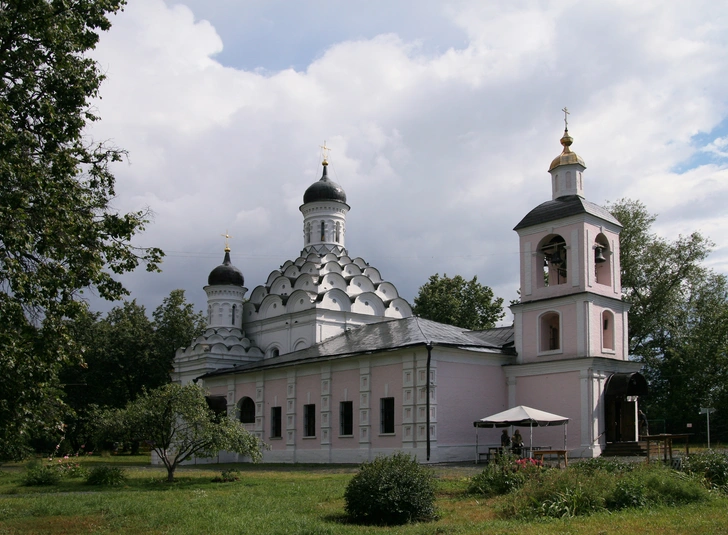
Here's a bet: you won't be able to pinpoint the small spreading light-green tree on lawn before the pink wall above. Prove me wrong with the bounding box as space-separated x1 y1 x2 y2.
99 383 264 482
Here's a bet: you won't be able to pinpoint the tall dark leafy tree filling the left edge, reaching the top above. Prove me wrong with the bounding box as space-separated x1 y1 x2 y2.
0 0 162 458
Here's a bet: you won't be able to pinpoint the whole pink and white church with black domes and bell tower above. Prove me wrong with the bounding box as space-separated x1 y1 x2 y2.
174 123 646 463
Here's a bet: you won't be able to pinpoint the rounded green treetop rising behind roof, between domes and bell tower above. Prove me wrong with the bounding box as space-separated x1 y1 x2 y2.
413 273 505 330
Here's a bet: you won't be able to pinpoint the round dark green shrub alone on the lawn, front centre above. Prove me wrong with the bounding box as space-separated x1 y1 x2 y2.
344 452 435 525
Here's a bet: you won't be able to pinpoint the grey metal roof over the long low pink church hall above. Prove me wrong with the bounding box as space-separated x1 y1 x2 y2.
203 316 515 377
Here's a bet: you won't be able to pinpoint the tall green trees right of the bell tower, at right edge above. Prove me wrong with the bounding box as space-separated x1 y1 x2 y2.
606 199 728 436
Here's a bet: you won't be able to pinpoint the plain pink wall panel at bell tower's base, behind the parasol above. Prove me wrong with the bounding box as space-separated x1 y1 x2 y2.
516 372 582 449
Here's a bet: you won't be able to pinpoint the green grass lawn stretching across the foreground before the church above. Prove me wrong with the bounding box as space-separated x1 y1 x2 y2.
0 456 728 535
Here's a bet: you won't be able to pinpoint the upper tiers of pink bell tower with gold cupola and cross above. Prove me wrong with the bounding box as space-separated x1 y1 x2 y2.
512 118 629 363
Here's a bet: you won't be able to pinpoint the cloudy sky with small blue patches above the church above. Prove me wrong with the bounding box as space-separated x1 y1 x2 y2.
87 0 728 323
